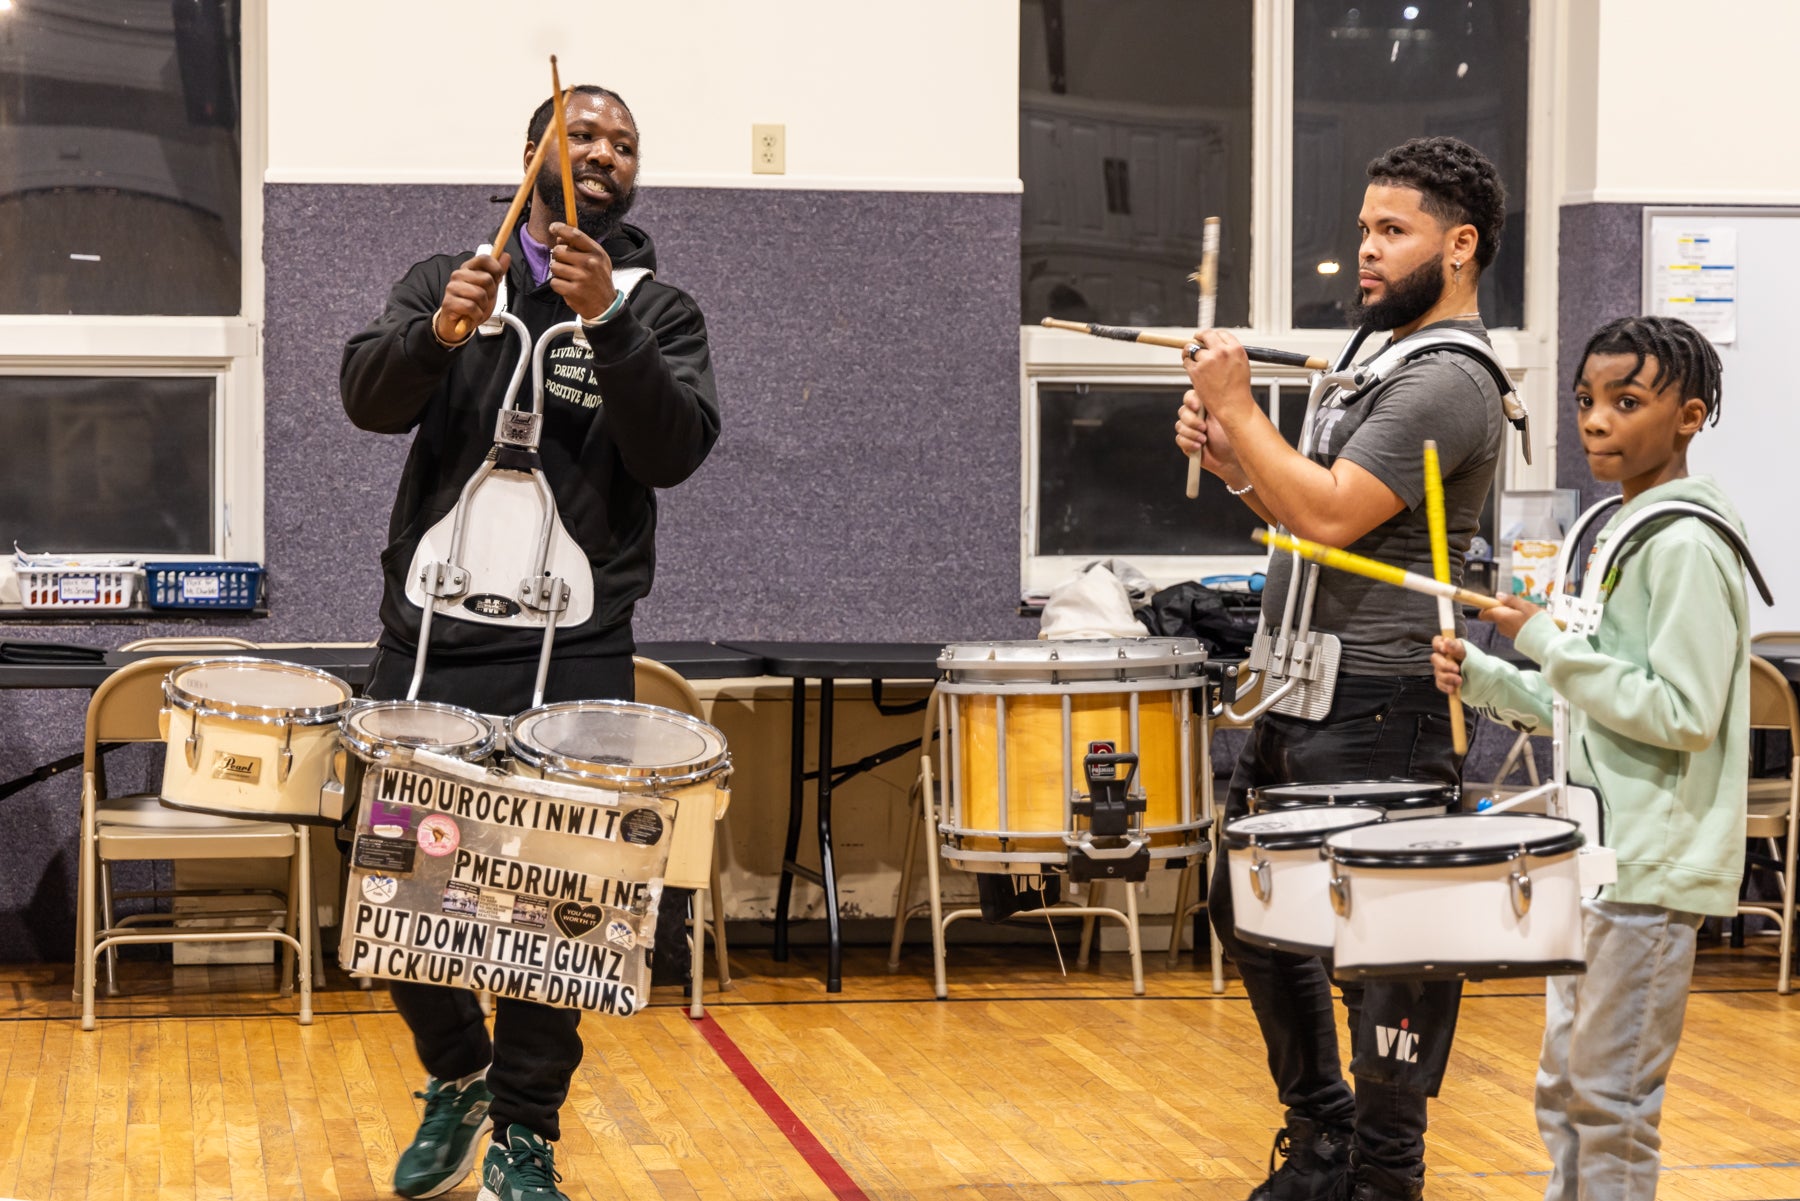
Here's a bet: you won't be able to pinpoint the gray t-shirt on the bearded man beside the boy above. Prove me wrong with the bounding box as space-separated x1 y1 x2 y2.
1262 319 1507 675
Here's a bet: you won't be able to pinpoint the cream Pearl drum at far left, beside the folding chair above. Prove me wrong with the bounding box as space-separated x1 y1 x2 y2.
162 659 351 825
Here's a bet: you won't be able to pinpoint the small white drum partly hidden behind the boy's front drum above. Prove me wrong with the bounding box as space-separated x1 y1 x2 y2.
1226 805 1382 954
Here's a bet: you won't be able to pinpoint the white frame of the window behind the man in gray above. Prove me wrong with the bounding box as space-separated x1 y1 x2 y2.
1019 0 1568 592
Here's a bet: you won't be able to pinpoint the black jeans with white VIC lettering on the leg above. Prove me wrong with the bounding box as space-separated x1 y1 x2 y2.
1208 675 1462 1176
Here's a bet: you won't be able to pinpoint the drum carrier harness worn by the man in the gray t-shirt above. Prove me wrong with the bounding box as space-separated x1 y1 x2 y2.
1224 330 1532 722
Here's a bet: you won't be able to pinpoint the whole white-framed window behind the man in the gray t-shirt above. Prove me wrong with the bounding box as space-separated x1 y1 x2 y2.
1019 0 1557 592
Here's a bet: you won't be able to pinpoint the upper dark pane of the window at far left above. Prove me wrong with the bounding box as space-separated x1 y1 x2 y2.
0 0 241 317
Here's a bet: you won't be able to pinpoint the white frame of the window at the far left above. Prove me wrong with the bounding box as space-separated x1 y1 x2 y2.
0 0 268 562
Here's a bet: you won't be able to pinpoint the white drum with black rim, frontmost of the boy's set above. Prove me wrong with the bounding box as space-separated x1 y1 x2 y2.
1325 814 1586 980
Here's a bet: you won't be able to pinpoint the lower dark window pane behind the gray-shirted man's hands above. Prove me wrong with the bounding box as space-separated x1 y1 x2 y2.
1037 384 1269 558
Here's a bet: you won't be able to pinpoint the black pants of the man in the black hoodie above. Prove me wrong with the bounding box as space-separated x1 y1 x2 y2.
369 648 637 1142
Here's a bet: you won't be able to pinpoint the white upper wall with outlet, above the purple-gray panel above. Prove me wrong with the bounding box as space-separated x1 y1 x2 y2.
266 0 1019 191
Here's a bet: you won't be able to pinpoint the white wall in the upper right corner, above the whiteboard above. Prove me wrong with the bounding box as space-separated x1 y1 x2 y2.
1559 0 1800 203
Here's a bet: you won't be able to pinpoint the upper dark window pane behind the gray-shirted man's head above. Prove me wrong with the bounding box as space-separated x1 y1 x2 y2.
1292 0 1532 328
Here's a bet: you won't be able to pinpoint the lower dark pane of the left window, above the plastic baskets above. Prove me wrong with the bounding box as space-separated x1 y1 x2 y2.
0 375 214 555
